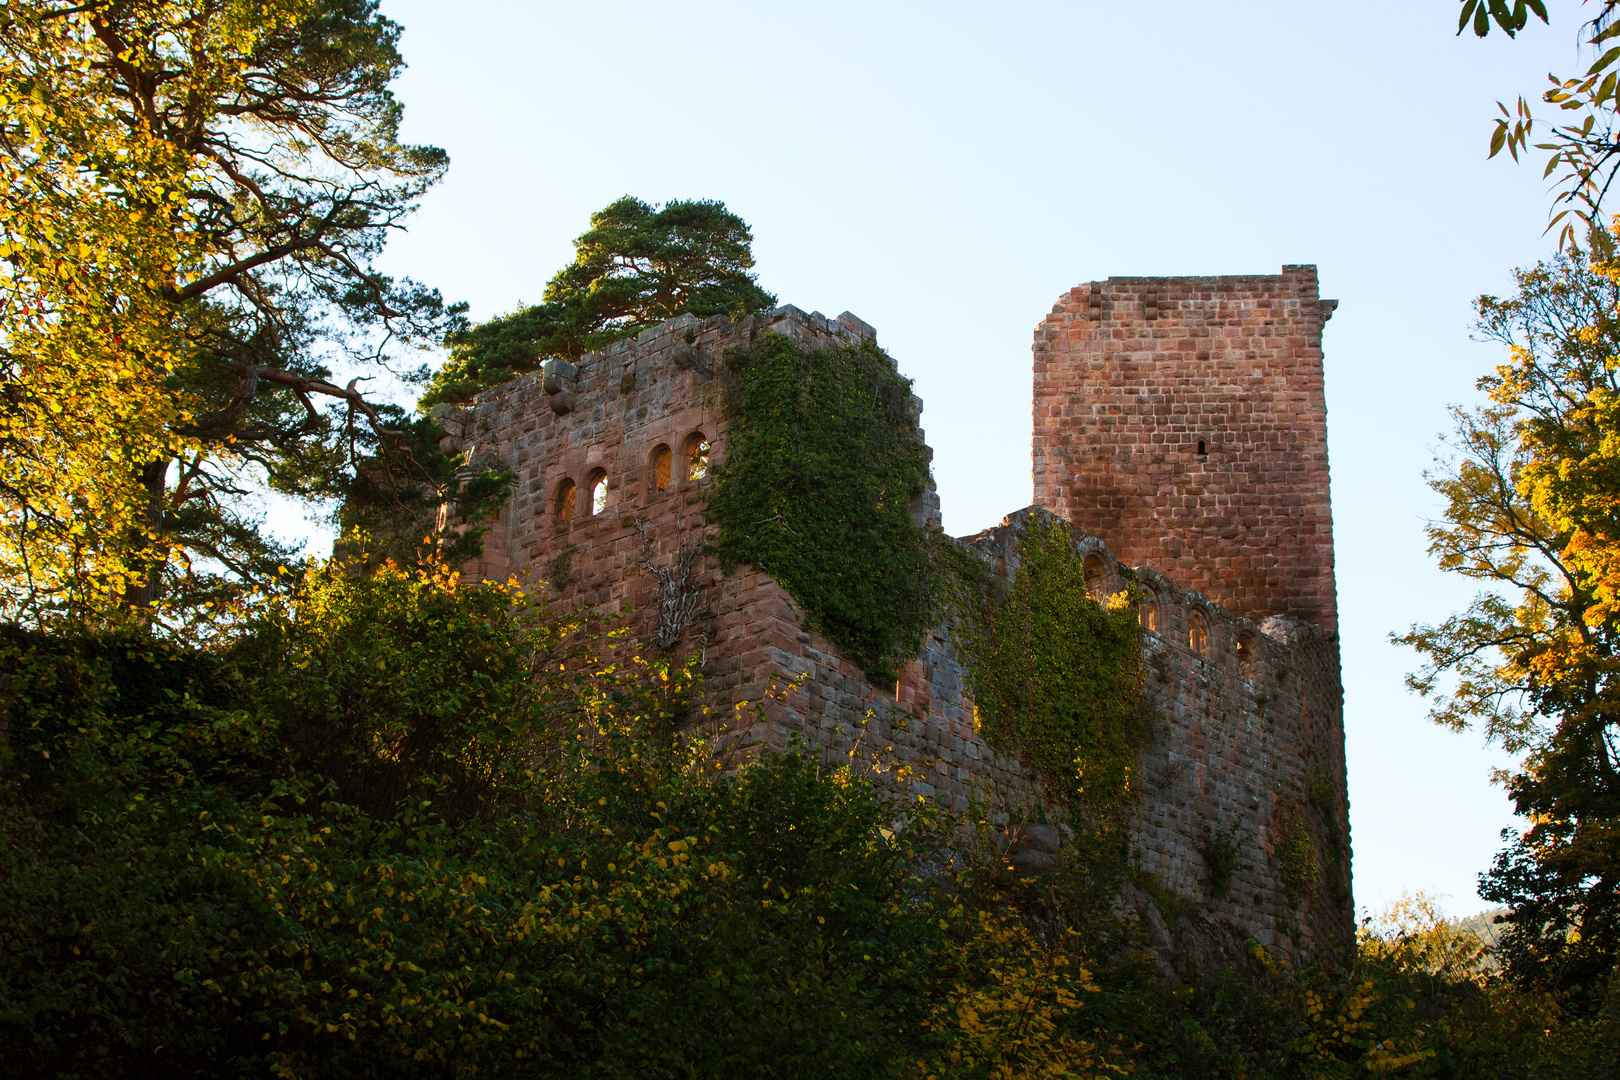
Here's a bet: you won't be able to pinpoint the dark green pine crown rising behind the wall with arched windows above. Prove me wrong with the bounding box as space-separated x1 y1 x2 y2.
421 196 776 406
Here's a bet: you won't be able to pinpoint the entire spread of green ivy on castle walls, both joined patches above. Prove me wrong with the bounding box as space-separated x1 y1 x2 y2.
708 334 1149 809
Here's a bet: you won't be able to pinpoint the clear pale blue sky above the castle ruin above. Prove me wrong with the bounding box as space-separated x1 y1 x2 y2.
345 0 1581 913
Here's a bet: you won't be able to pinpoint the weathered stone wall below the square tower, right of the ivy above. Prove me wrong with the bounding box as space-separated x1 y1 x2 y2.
953 507 1354 952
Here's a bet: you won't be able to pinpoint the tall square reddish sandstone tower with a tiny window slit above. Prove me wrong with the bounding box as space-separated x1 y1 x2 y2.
1034 266 1338 630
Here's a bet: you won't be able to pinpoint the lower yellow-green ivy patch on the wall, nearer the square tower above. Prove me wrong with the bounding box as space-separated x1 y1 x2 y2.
956 521 1150 818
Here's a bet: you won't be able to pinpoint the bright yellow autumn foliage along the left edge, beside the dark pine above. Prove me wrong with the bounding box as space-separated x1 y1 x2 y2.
0 0 325 625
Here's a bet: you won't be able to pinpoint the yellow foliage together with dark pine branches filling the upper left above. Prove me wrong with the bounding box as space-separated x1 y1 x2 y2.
0 0 505 634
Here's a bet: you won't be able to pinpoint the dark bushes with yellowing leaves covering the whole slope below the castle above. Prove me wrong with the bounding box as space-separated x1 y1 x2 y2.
0 567 1620 1078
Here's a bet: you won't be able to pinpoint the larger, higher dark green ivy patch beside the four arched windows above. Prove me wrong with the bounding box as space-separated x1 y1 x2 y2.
708 334 935 683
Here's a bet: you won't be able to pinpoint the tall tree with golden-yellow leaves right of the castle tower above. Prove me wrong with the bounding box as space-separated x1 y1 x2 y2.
1398 247 1620 986
